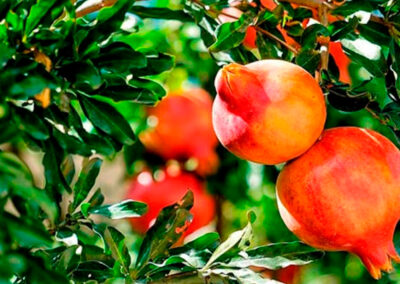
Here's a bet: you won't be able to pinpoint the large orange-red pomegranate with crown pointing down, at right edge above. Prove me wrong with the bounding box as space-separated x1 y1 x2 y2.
277 127 400 279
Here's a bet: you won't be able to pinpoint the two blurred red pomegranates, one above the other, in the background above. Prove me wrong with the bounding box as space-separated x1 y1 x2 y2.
127 89 219 235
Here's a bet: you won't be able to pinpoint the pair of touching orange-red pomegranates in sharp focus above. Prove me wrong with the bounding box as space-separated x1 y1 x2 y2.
212 60 400 279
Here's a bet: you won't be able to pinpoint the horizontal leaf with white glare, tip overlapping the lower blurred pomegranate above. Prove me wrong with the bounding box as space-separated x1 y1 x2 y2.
88 200 148 219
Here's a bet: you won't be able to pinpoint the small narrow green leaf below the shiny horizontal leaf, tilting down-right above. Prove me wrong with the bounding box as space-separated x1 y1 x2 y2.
104 227 131 275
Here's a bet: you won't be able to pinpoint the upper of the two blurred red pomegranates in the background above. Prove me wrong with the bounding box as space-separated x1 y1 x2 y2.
139 89 219 175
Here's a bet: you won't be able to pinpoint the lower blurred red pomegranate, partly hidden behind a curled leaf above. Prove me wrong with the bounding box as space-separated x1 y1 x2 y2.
127 170 215 235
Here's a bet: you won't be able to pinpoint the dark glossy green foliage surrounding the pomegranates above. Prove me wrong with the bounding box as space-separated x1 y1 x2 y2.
0 0 400 283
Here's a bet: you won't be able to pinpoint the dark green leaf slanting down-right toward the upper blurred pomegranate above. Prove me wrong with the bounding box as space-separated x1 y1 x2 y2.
79 95 135 145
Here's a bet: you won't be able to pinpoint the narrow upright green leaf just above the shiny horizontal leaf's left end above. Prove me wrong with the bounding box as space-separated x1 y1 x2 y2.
72 158 102 211
